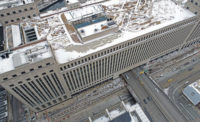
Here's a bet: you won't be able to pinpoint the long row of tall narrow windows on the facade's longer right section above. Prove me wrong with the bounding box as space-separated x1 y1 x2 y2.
63 25 195 95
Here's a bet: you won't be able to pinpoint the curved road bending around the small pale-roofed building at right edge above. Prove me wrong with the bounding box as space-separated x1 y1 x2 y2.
168 63 200 121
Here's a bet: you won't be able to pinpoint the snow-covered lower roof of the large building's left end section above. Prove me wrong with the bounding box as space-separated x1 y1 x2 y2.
0 41 52 74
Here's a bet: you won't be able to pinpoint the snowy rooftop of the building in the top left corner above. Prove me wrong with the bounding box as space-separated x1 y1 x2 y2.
0 0 34 10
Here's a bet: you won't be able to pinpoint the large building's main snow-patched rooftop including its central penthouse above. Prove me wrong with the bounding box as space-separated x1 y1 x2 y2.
0 0 195 74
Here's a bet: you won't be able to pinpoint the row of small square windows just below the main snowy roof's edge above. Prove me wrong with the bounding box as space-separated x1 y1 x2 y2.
60 19 196 71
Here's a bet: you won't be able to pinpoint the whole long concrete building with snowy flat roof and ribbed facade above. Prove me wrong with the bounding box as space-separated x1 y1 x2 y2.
0 0 200 112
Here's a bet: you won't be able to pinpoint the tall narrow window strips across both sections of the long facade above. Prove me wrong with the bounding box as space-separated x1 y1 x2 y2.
5 21 199 109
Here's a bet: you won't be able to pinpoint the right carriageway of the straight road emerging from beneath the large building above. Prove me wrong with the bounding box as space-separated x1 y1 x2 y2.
132 68 187 122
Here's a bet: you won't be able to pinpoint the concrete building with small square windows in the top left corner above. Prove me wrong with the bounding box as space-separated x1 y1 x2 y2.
0 0 39 25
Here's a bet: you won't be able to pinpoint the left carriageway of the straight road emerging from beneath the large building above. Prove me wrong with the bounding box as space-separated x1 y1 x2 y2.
123 71 168 122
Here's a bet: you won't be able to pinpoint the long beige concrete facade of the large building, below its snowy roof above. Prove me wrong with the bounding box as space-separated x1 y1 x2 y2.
0 16 200 112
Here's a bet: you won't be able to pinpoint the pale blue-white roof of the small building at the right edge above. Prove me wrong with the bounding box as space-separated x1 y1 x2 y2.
183 80 200 105
